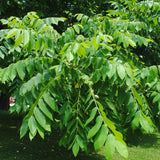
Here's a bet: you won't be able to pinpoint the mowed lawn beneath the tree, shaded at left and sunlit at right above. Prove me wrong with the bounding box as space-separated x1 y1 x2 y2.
0 112 160 160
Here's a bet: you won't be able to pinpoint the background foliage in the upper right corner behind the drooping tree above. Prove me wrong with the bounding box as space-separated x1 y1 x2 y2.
109 0 160 65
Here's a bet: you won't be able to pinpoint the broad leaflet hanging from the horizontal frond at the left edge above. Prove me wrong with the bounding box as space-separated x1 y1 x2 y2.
16 61 25 80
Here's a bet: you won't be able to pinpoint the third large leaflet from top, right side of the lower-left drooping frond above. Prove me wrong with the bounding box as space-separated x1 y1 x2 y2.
34 107 46 129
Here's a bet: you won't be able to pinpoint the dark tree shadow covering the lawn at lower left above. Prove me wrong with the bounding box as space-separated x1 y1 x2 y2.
0 113 105 160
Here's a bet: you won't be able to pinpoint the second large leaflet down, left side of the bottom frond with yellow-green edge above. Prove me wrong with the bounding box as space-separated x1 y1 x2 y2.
87 116 103 139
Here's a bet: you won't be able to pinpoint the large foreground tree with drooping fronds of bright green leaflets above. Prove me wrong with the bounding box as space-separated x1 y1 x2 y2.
0 0 160 159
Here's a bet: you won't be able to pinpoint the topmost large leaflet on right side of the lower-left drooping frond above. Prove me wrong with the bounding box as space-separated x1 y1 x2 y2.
43 92 58 112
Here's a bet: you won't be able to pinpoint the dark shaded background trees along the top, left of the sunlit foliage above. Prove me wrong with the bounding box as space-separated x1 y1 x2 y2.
0 0 110 18
